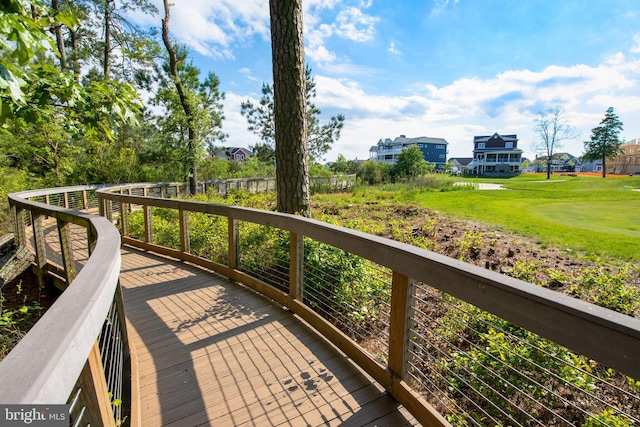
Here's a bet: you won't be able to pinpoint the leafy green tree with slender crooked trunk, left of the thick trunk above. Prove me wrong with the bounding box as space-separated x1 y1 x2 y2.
155 0 225 194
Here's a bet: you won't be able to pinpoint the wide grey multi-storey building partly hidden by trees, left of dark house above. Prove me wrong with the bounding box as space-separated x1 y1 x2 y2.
369 135 449 169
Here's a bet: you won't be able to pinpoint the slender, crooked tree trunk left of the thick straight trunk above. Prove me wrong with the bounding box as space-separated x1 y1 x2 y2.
162 0 198 195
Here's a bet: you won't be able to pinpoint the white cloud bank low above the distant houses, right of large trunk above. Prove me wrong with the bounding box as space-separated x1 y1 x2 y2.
300 50 640 164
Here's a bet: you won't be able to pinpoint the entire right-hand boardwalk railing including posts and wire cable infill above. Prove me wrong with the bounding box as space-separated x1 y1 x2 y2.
98 186 640 425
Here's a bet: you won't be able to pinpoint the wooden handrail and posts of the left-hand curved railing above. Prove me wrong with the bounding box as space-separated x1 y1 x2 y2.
0 186 126 425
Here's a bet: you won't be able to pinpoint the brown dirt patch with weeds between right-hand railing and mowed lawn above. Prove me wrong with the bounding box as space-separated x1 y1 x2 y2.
314 201 640 317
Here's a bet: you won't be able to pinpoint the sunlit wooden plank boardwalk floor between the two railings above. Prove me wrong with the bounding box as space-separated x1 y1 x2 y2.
120 247 417 426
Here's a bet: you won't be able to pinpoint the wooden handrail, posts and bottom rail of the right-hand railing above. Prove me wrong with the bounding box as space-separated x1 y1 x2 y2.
97 186 640 425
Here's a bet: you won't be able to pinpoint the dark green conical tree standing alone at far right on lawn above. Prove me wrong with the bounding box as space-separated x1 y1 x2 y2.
583 107 623 178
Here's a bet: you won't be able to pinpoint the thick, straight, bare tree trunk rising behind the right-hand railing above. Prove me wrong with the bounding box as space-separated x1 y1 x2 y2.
270 0 311 216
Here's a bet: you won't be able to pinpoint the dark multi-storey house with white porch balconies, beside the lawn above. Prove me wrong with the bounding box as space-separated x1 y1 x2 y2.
468 132 522 176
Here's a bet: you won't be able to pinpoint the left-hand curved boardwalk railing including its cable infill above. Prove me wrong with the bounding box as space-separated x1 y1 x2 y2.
0 186 131 426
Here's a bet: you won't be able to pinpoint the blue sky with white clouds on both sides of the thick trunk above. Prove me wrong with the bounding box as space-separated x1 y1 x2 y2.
129 0 640 161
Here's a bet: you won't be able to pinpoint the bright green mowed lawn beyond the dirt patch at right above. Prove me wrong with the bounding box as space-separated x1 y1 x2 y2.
350 174 640 262
